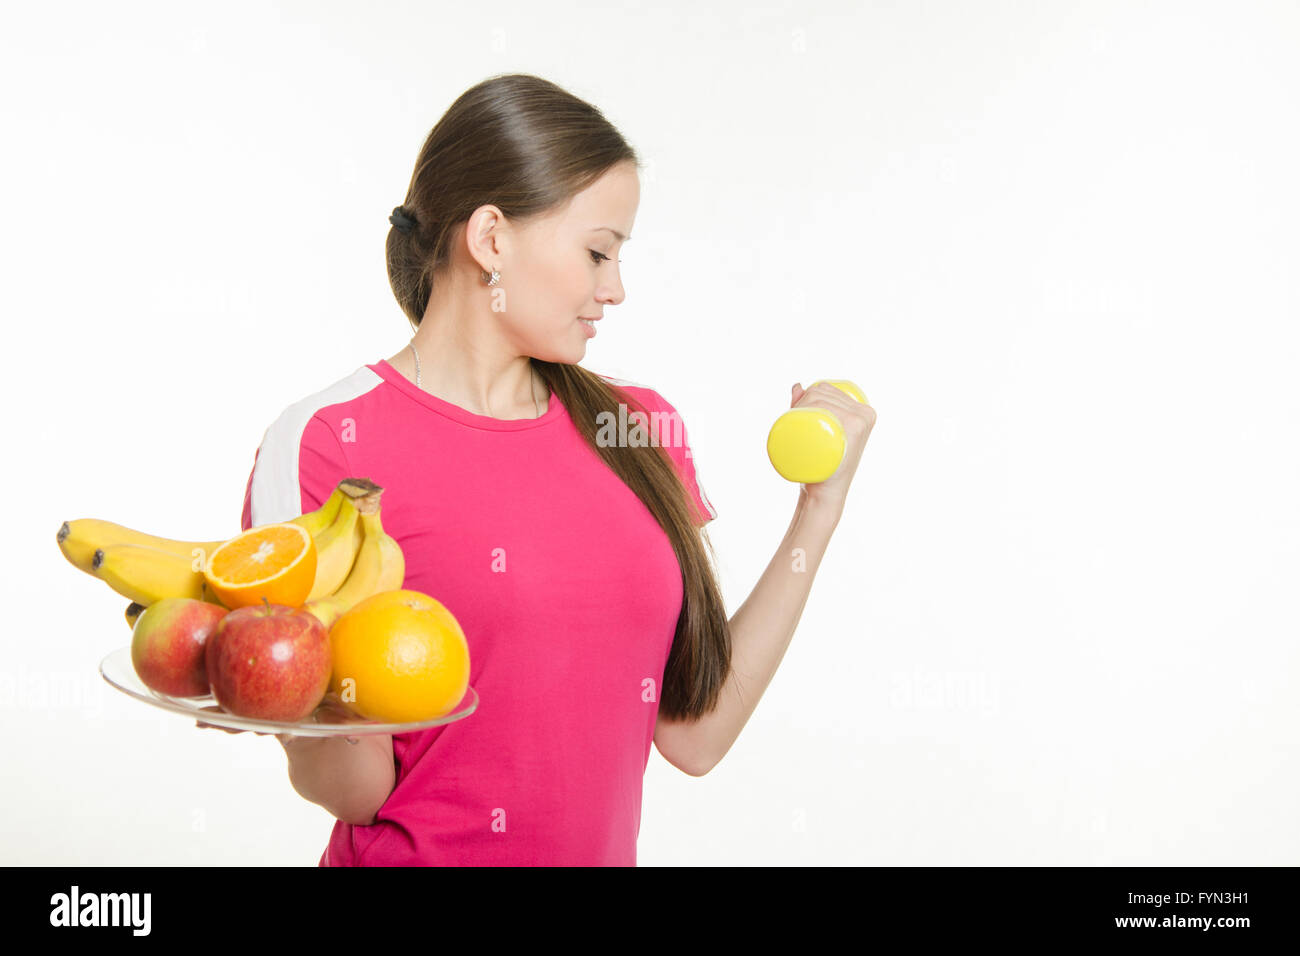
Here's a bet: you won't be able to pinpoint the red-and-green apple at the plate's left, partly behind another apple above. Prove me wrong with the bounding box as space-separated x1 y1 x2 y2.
131 597 229 697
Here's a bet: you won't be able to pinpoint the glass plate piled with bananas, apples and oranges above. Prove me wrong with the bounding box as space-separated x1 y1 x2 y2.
56 477 478 737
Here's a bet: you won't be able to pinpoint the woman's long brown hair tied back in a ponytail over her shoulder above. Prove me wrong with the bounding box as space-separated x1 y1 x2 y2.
387 73 732 719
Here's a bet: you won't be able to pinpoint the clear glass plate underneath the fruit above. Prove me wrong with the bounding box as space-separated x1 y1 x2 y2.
99 644 478 737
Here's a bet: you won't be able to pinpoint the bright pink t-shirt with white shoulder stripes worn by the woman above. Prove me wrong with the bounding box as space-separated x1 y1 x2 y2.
242 359 716 866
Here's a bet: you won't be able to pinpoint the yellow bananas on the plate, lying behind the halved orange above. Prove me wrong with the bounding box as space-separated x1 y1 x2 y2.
56 479 387 627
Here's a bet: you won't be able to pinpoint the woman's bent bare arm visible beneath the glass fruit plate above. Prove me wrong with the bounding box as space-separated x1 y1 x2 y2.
281 735 397 826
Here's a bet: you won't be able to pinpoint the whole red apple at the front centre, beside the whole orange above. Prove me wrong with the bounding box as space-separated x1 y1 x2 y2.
205 598 333 723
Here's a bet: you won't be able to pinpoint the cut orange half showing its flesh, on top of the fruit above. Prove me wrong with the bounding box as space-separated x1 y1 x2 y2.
203 522 316 610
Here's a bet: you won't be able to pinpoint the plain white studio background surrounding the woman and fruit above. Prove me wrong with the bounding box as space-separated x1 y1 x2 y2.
0 0 1300 865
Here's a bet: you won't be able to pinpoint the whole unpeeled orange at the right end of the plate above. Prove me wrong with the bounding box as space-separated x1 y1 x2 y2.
329 589 469 723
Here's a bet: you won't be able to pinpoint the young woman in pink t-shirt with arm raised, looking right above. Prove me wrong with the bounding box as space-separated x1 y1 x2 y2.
228 74 875 866
